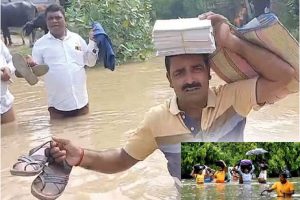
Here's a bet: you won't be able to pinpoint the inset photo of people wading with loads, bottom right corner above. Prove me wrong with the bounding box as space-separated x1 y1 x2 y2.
181 142 300 200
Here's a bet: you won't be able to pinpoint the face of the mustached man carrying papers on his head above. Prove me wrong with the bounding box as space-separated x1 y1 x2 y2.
167 54 209 103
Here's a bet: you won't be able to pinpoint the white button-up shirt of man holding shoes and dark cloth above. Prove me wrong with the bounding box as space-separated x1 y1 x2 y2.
32 30 98 111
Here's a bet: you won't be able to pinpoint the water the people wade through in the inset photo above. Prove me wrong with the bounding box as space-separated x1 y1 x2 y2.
181 177 300 200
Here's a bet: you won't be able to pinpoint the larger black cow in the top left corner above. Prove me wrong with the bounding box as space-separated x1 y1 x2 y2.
1 1 37 45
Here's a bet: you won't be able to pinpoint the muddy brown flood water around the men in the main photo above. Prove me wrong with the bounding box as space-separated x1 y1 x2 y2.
1 55 299 200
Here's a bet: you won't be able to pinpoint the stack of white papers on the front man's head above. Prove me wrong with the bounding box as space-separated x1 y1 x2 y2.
153 18 216 56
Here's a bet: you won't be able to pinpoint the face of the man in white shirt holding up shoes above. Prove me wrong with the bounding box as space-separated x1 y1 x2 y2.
46 11 66 38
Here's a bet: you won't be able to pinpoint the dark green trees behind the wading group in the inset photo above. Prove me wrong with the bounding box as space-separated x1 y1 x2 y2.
181 142 300 177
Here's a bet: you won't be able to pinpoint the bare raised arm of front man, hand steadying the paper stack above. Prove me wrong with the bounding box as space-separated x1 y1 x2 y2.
199 12 296 104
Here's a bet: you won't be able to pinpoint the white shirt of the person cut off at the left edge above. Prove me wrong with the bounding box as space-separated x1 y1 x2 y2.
0 40 16 115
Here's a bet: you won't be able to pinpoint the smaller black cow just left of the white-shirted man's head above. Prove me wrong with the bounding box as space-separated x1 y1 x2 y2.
23 12 49 38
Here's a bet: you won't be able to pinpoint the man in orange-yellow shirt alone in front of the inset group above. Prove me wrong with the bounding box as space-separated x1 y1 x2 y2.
267 173 295 197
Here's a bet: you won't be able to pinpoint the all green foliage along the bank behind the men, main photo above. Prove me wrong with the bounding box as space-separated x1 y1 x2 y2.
67 0 299 63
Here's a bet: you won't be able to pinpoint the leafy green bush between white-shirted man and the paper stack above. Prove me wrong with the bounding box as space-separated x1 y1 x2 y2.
67 0 153 63
